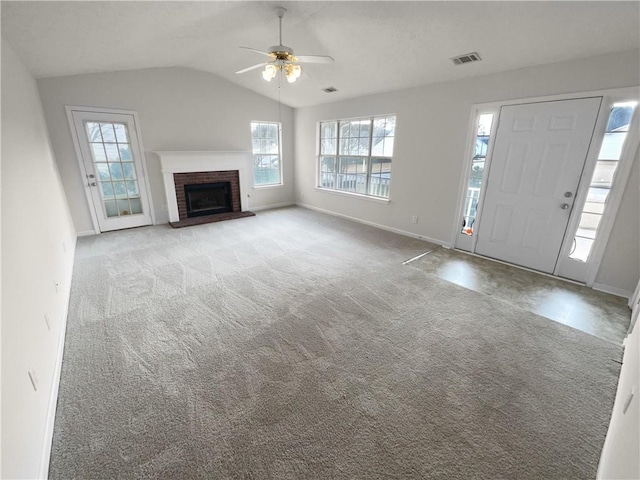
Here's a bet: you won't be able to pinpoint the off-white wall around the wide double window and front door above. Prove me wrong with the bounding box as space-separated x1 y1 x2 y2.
295 50 640 291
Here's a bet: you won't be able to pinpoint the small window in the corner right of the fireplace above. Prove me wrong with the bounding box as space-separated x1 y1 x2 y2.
251 122 282 186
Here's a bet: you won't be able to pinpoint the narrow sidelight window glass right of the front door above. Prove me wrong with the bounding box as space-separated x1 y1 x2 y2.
569 102 637 262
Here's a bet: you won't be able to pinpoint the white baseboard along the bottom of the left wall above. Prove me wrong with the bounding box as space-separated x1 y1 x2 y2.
39 233 77 479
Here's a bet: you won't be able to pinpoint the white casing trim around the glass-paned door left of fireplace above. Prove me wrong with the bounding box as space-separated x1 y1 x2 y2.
65 105 157 235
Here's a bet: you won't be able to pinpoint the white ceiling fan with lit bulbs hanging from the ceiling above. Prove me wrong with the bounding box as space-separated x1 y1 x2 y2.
236 7 334 83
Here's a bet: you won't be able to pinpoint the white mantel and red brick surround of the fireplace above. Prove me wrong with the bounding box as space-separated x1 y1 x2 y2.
155 152 251 226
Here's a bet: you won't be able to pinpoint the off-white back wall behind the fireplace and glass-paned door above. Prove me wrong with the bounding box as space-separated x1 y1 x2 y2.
38 68 294 233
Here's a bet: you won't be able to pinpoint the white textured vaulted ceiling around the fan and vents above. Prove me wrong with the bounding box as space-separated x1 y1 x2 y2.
1 1 640 107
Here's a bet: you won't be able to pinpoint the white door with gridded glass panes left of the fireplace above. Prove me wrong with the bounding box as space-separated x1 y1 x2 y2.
70 110 152 232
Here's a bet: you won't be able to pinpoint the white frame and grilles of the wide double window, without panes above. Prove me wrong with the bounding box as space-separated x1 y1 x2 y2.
315 113 397 203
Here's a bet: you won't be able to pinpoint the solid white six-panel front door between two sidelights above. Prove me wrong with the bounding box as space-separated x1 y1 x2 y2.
475 97 602 273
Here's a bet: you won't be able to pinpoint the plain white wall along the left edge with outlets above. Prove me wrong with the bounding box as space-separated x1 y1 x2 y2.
1 39 76 478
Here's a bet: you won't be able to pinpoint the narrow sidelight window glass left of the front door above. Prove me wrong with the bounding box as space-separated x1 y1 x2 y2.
461 113 493 235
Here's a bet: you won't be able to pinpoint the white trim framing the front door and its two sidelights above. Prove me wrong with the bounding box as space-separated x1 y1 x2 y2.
451 86 640 287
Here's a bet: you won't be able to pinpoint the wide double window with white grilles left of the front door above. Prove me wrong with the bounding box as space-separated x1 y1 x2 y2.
318 115 396 198
